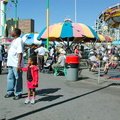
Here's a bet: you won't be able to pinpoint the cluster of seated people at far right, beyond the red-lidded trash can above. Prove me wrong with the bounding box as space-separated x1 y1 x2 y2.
88 45 120 74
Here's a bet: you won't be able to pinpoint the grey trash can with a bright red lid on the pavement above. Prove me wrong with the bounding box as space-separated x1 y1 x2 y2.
65 55 79 81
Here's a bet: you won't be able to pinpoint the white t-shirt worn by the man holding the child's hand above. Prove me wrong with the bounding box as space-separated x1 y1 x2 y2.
7 37 24 67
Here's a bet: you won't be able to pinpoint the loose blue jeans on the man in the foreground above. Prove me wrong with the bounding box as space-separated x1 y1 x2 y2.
7 66 23 95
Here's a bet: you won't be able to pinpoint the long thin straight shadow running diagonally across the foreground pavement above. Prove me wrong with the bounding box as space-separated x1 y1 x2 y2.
8 85 111 120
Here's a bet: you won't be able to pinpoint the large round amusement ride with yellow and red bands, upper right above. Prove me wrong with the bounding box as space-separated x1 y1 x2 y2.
95 3 120 40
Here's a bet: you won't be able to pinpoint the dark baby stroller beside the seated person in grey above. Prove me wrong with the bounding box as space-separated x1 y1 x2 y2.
41 57 54 73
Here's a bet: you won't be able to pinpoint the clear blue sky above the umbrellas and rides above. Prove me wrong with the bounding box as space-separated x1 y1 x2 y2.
7 0 120 33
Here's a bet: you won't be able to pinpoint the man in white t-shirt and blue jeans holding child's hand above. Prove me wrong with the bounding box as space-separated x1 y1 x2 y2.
5 28 24 100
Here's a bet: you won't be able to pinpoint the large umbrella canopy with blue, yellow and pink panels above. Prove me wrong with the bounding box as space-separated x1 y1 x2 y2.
37 22 99 41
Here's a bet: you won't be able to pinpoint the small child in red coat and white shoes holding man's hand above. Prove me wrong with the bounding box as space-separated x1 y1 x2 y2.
21 56 38 104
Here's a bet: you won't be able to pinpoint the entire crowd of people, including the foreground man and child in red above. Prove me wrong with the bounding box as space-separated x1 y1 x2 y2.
0 28 120 104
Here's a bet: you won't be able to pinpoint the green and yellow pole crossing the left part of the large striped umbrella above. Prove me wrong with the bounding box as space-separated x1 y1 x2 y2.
46 0 49 49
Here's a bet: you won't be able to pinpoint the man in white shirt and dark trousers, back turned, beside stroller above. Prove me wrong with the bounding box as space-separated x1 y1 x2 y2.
35 44 49 72
